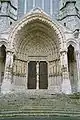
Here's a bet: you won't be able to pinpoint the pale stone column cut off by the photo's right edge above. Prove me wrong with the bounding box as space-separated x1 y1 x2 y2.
75 51 80 92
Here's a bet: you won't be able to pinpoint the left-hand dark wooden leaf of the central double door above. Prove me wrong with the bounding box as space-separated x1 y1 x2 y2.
27 61 36 89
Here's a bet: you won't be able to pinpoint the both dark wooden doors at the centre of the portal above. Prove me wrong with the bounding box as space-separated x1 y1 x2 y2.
27 61 48 89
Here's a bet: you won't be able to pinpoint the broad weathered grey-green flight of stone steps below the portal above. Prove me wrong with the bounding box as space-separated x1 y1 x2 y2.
0 92 80 118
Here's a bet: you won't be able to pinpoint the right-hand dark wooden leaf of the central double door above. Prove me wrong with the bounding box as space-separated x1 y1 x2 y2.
39 61 48 89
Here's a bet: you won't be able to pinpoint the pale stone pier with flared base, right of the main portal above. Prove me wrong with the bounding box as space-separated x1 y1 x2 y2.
60 51 71 94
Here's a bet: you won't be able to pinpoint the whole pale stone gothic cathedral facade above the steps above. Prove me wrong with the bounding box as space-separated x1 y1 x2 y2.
0 0 80 94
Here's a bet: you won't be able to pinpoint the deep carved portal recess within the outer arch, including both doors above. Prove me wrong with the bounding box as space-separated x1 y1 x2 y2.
13 20 62 93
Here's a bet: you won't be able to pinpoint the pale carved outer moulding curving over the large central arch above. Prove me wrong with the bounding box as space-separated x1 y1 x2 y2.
8 13 65 51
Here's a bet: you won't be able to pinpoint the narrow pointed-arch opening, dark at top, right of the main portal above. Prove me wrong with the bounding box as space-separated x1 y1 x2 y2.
68 45 78 92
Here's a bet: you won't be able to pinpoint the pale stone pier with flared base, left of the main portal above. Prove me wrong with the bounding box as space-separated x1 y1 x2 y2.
1 51 13 94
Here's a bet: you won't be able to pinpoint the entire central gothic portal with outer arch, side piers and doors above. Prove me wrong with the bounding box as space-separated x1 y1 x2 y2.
2 11 70 94
